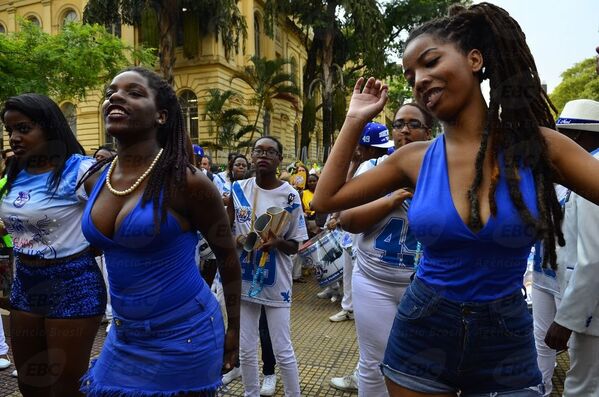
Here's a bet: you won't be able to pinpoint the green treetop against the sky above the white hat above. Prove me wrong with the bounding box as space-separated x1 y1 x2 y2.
549 58 599 114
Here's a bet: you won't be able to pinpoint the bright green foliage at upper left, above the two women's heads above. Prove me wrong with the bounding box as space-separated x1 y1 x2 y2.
0 21 155 102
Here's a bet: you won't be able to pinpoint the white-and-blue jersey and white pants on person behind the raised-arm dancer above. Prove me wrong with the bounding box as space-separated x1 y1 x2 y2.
352 155 418 397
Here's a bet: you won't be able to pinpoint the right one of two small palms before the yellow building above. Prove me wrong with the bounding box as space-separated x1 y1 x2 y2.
231 55 299 152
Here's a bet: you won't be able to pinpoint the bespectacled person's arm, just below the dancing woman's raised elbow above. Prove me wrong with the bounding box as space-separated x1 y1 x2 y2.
339 189 412 233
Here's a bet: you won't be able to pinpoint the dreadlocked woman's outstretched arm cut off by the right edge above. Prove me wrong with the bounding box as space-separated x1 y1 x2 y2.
541 127 599 205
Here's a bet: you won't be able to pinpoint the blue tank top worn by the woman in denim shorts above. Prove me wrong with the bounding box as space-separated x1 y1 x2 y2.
408 135 538 302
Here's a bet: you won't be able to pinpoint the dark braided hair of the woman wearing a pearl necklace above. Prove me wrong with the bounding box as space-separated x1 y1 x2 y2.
79 67 195 232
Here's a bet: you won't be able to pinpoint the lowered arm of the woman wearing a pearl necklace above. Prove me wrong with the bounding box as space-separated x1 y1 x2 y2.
185 171 241 370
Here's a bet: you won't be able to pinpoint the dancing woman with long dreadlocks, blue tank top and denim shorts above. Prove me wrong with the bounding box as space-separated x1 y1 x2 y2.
312 3 599 396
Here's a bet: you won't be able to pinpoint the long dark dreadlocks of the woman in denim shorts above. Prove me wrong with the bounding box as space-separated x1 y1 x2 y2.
406 3 565 269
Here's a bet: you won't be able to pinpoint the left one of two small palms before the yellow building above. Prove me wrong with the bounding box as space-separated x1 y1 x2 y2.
200 88 255 162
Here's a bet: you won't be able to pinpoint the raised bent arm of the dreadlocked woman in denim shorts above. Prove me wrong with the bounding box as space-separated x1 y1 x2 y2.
312 77 412 213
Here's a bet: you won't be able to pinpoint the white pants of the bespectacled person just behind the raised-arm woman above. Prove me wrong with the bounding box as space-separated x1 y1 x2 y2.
352 266 407 397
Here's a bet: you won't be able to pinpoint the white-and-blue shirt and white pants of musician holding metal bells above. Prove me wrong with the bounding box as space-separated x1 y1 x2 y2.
231 178 308 397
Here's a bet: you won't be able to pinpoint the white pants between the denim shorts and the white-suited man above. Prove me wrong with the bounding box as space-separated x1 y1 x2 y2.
532 288 560 396
